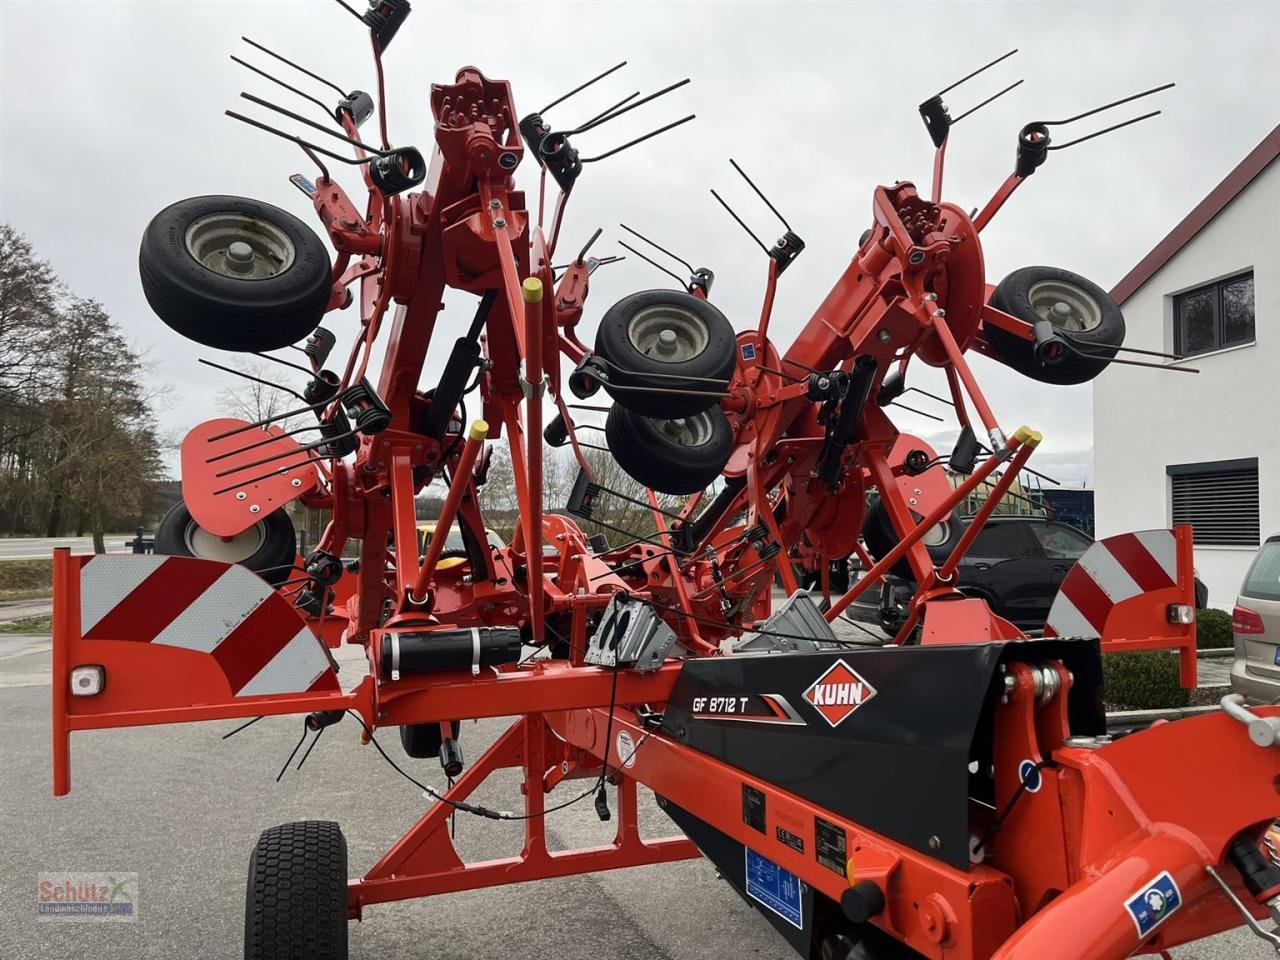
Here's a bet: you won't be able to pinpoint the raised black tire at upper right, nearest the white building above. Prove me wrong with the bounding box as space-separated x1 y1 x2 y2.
983 266 1125 384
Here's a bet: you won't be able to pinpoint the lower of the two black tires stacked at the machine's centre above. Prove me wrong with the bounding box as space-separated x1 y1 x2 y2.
604 403 733 495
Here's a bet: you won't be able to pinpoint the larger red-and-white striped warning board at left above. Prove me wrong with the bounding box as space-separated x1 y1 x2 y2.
79 556 338 698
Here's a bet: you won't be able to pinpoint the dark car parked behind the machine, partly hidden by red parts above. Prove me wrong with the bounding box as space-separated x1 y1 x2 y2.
846 516 1207 631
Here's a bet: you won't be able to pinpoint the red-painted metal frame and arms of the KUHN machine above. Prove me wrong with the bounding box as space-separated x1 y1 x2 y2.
54 28 1280 960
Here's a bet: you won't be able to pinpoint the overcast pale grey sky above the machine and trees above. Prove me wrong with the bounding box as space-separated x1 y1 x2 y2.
0 0 1280 483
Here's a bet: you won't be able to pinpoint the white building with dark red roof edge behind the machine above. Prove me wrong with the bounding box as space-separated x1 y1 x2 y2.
1093 127 1280 609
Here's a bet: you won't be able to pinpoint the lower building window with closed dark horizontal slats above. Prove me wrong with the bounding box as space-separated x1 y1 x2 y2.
1165 457 1261 547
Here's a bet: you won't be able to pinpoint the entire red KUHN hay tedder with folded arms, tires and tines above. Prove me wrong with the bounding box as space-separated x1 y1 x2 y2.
54 0 1280 960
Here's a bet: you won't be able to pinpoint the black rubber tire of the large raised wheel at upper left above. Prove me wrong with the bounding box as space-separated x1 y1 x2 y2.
138 196 333 351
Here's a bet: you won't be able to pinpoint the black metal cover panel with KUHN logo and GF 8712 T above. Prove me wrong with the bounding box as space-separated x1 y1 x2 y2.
663 640 1105 868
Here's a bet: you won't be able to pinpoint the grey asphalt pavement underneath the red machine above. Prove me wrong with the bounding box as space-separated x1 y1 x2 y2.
0 635 1275 960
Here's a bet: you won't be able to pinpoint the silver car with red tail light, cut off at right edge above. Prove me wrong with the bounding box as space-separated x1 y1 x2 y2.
1231 535 1280 703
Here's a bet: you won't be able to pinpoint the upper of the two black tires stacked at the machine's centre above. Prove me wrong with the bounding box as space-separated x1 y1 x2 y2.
595 291 737 417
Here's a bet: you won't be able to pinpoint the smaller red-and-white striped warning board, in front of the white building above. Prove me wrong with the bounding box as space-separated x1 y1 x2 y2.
1044 530 1172 636
